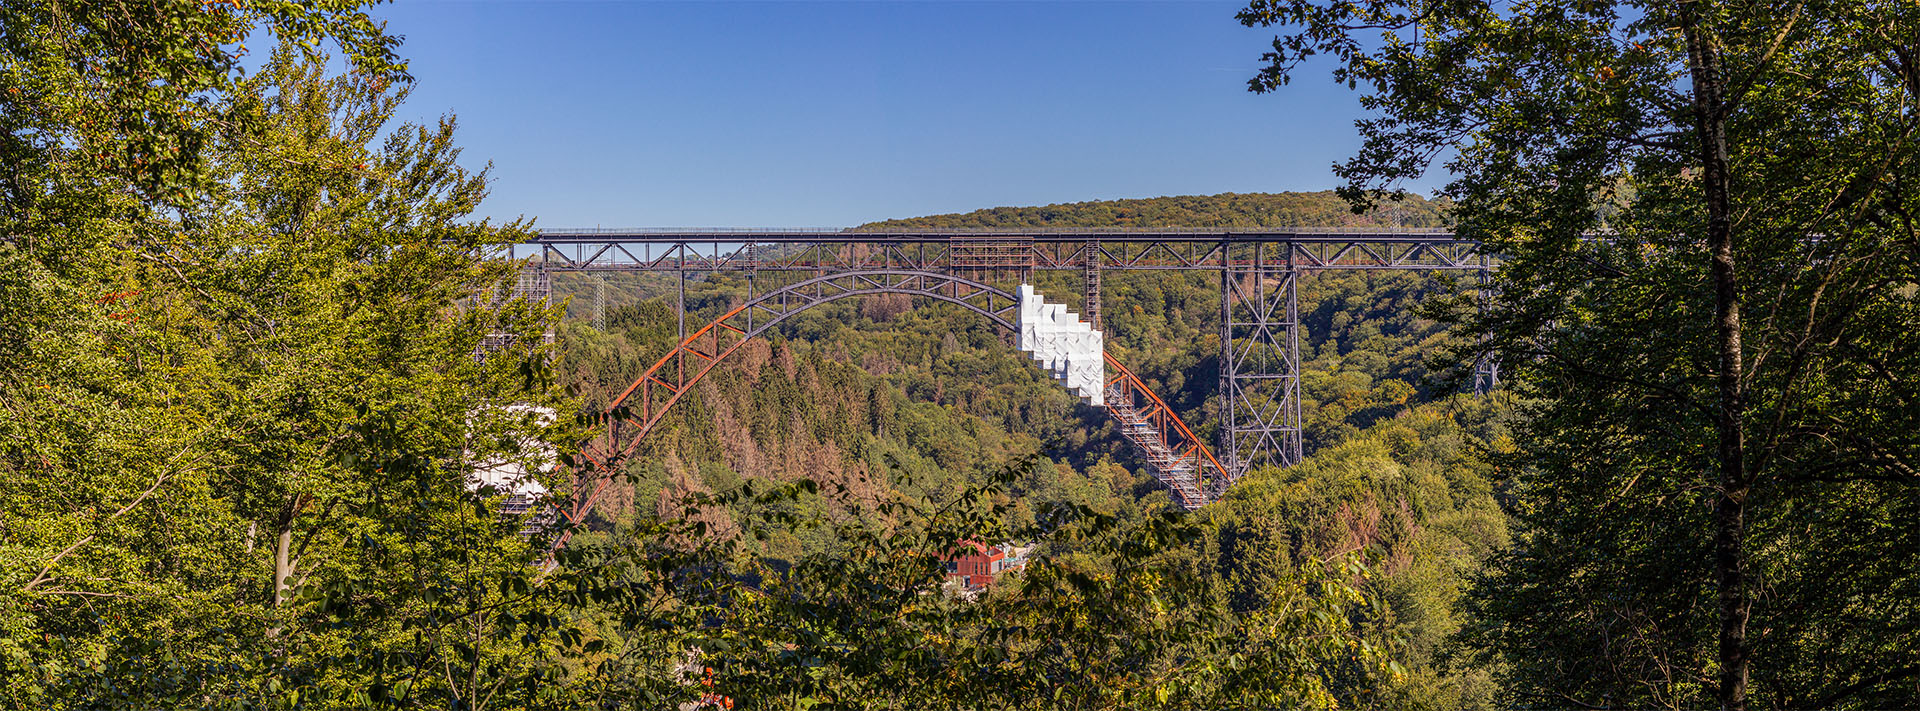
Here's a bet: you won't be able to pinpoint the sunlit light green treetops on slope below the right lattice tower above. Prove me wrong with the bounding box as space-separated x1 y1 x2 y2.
1206 398 1509 709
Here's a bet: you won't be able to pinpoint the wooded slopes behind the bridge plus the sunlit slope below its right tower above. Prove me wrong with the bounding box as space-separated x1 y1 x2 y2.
555 192 1505 705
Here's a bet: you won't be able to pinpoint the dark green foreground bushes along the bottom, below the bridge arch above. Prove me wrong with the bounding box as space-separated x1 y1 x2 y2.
556 459 1396 709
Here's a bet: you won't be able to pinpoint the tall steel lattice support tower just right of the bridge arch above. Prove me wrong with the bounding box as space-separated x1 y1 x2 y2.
1210 242 1302 478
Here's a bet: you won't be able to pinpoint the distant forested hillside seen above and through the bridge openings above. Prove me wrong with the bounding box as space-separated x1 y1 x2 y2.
555 192 1474 526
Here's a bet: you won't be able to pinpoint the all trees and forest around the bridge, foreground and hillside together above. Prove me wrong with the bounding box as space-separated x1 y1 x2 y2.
0 0 1920 711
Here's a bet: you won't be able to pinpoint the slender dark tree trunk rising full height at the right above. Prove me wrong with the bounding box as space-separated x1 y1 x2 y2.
1680 0 1753 711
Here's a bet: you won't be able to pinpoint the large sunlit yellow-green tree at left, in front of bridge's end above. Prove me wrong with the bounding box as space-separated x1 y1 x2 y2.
0 52 574 709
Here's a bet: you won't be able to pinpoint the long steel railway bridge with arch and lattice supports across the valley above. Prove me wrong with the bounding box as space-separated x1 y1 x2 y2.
516 229 1500 525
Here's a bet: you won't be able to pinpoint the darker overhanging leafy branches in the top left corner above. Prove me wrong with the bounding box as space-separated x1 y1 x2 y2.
0 0 407 202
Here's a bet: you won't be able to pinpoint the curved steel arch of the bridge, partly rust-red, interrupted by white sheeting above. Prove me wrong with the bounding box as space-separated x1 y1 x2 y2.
561 269 1233 525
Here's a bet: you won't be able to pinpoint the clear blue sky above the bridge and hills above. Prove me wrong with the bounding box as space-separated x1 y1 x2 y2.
374 0 1397 227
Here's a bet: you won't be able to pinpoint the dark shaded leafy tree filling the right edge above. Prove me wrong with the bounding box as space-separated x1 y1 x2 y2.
1240 0 1920 709
